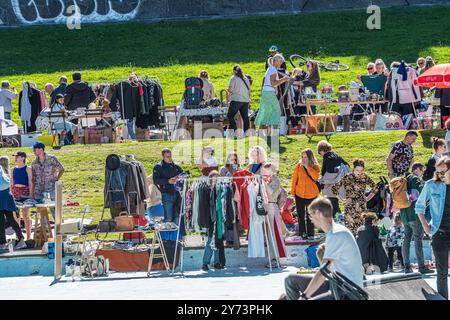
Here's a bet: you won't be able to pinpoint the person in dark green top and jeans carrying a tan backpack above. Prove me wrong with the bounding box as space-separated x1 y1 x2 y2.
400 162 434 274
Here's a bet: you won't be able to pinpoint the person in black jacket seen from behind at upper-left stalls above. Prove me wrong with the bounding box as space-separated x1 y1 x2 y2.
64 72 97 111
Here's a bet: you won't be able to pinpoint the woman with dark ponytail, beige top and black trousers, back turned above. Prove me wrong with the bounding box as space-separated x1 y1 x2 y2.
227 64 251 136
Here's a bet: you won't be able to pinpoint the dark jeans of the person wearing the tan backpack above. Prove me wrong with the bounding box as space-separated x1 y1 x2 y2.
402 221 425 269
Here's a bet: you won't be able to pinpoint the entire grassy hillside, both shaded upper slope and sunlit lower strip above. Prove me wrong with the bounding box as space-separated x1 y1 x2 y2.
0 6 450 219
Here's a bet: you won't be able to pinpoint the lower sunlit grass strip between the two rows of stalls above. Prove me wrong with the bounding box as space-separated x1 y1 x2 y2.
1 131 445 219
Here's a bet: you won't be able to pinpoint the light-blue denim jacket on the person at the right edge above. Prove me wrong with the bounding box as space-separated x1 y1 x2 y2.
416 180 447 235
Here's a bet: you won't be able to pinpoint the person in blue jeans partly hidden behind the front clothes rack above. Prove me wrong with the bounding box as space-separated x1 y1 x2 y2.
202 171 226 271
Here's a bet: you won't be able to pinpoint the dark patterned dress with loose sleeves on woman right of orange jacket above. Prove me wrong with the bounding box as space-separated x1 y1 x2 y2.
331 172 377 235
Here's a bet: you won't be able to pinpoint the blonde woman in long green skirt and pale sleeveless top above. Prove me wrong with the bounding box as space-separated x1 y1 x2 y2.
255 54 290 134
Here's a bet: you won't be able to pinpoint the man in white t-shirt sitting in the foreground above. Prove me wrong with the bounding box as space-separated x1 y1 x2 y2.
285 197 363 300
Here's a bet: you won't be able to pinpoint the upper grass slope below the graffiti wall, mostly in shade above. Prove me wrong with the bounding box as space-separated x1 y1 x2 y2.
0 6 450 125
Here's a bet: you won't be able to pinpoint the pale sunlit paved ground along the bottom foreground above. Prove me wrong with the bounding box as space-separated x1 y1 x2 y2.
0 267 448 300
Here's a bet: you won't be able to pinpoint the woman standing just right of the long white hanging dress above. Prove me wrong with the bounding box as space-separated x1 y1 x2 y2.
261 163 286 268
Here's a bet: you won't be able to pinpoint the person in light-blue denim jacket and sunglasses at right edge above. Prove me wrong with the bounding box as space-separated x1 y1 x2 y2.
416 157 450 299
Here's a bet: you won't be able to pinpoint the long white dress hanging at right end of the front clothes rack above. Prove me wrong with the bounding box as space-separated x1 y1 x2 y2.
246 182 266 258
